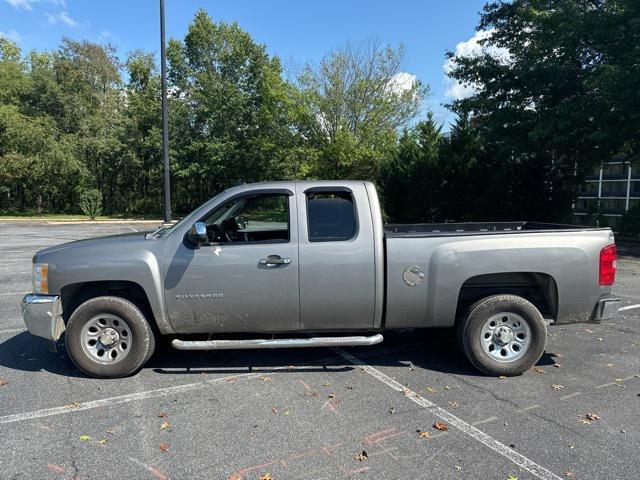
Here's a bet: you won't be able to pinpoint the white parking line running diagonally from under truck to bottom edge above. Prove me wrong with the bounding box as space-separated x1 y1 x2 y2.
332 348 562 480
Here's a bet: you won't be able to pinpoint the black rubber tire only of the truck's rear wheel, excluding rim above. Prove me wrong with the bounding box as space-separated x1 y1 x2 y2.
456 295 547 376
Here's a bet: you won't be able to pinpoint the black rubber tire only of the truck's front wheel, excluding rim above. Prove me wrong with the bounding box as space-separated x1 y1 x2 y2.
65 296 155 378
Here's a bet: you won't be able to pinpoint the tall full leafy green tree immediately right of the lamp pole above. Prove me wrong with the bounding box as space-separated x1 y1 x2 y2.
168 10 302 208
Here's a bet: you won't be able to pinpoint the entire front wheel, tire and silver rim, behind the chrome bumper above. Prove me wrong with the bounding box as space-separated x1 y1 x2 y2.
65 296 155 378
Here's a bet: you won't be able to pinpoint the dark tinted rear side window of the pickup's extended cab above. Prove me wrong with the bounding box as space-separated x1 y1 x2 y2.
307 191 356 242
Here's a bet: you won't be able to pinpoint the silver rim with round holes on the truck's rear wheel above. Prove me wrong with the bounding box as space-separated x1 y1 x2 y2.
480 312 531 362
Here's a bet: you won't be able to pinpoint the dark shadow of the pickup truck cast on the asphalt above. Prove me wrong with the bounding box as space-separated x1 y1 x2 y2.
0 329 555 378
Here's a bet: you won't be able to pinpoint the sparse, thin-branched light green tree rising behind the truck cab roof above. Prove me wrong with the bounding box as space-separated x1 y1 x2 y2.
298 42 427 180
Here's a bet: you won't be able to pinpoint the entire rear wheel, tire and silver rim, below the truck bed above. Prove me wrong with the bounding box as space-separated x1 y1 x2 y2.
457 295 547 376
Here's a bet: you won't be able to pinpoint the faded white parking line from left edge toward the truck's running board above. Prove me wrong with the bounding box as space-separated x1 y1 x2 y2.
0 373 262 424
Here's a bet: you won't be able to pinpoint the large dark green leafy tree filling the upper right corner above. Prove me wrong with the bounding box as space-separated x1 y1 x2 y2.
449 0 640 220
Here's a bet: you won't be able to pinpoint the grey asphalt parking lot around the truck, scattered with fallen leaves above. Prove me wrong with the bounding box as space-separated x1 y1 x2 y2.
0 223 640 480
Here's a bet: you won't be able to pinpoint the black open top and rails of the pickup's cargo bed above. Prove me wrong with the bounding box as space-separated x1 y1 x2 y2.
384 222 606 238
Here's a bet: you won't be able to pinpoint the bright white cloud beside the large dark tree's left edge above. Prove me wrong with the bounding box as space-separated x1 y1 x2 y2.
442 29 509 100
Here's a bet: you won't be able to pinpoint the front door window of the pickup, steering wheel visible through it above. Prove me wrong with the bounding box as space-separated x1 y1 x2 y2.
203 194 289 243
